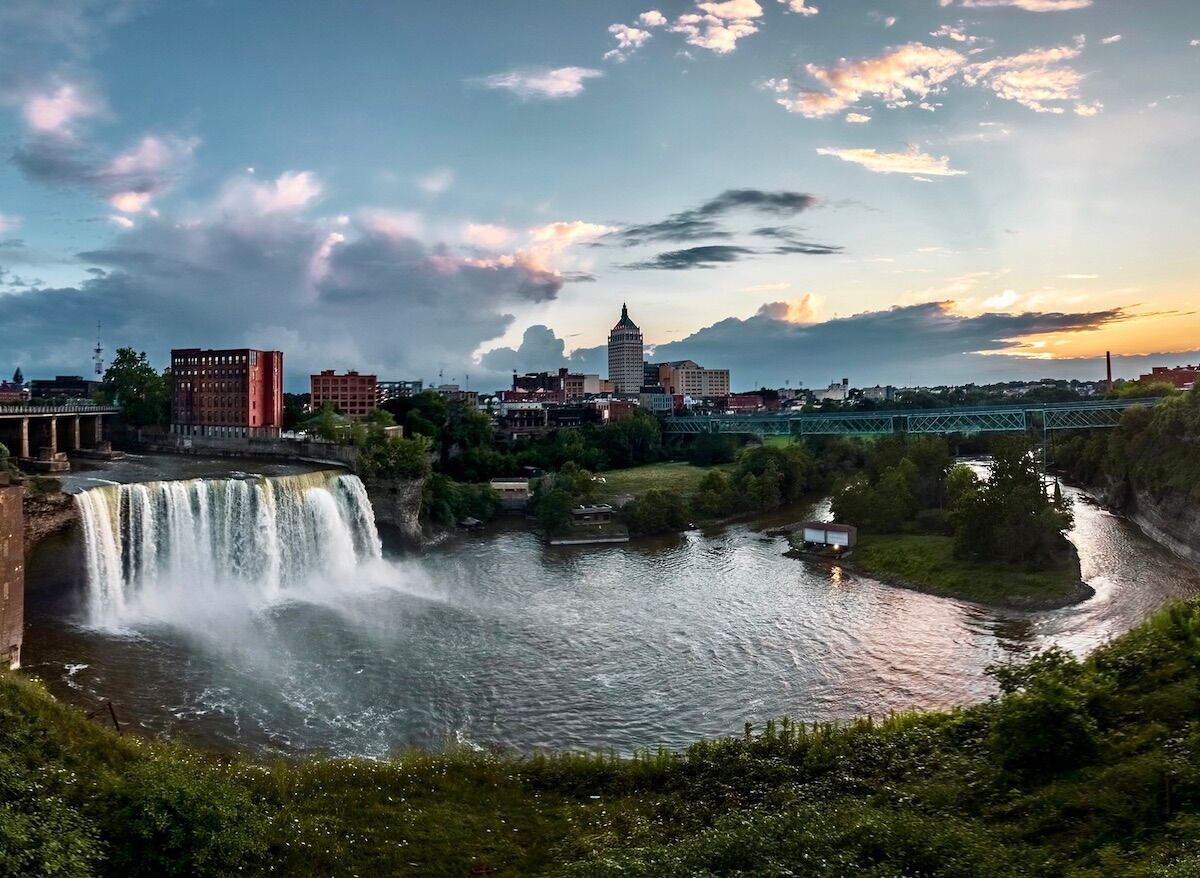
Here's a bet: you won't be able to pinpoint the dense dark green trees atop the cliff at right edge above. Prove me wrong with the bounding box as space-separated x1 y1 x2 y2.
1054 389 1200 503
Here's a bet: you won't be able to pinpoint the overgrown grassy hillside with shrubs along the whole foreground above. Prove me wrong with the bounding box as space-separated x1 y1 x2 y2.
7 603 1200 878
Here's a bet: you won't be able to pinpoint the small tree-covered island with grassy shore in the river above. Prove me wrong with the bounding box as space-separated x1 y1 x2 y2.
790 437 1094 611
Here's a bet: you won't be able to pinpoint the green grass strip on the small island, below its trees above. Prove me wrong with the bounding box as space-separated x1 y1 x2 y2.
848 534 1080 606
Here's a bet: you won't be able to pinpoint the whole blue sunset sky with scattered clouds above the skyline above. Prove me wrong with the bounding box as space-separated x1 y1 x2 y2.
0 0 1200 390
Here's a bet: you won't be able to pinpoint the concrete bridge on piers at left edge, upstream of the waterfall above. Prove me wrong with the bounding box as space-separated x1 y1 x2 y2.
0 403 120 473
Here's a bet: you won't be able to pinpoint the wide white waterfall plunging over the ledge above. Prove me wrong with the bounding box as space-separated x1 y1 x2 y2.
76 471 382 626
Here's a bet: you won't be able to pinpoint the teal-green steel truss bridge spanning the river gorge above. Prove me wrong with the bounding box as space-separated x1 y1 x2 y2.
662 398 1158 438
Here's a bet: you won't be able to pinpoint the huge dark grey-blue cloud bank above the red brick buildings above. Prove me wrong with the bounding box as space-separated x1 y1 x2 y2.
0 211 576 386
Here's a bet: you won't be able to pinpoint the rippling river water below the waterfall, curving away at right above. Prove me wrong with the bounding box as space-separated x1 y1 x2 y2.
24 462 1200 757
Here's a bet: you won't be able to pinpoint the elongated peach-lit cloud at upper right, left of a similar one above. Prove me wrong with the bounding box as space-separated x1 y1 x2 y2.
766 43 966 119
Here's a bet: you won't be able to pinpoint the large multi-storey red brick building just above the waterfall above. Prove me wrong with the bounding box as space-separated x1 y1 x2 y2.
170 348 283 438
